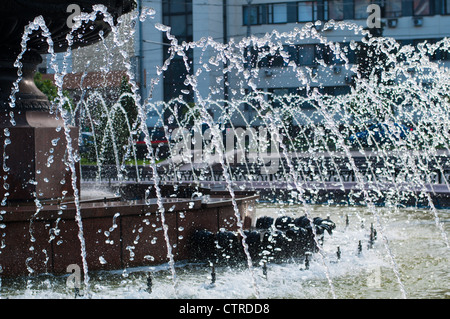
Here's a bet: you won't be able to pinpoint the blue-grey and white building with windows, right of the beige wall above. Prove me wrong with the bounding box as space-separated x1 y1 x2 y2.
135 0 450 125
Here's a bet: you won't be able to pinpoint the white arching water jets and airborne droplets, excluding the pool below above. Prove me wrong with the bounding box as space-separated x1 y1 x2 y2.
3 6 450 298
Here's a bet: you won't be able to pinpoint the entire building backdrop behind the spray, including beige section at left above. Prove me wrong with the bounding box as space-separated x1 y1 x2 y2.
42 0 450 127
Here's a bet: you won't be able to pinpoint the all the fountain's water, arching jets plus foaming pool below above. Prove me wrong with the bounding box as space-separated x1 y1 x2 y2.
0 6 450 298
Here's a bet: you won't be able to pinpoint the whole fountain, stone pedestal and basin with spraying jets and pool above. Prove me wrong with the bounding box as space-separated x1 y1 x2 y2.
0 0 450 298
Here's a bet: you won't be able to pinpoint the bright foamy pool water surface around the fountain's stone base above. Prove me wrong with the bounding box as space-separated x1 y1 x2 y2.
0 204 450 298
